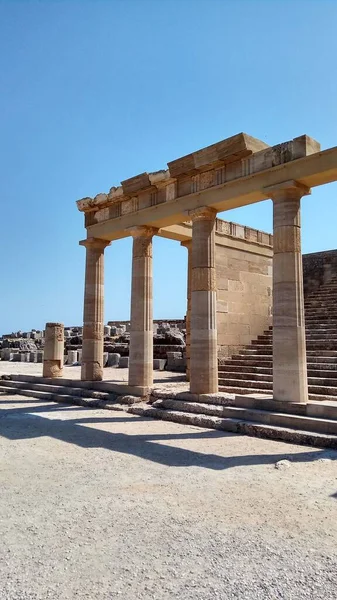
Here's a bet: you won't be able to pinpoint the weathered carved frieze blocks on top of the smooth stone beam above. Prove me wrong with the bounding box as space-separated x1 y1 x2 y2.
77 133 320 232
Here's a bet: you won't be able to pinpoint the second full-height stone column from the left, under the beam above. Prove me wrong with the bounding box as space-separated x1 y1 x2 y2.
129 226 158 388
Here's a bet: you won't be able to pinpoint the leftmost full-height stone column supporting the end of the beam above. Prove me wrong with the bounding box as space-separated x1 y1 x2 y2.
80 238 110 381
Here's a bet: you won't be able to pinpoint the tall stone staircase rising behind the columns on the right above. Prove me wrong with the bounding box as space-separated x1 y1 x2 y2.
219 278 337 402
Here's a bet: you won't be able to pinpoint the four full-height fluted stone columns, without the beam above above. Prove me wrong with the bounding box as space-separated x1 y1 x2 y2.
80 181 310 402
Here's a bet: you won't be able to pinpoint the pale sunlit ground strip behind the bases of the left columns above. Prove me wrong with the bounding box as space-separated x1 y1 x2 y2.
0 361 189 391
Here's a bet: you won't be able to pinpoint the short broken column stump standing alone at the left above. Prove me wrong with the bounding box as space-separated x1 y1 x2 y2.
43 323 64 378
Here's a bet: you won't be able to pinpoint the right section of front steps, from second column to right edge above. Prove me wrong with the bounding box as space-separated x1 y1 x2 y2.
127 390 337 449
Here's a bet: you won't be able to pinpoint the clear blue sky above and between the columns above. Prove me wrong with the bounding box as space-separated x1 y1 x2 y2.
0 0 337 333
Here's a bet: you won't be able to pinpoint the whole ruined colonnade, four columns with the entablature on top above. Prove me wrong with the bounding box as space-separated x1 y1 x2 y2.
77 133 337 403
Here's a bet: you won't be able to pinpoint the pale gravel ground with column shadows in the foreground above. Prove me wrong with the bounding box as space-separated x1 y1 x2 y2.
0 395 337 600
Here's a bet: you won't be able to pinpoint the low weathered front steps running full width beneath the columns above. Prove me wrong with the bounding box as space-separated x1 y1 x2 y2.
0 375 337 450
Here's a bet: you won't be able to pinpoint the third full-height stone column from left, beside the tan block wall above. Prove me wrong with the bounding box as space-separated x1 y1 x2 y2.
190 207 218 394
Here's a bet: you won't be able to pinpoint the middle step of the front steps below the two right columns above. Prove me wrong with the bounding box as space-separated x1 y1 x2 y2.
152 399 337 439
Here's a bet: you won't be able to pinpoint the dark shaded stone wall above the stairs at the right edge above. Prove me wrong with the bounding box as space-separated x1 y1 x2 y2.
303 250 337 295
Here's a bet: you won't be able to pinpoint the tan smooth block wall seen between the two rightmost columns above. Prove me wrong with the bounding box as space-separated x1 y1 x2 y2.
216 220 273 359
